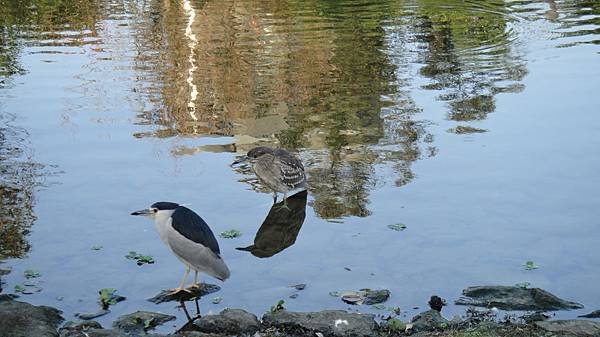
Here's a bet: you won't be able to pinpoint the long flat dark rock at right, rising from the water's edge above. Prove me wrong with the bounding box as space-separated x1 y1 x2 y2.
455 286 583 311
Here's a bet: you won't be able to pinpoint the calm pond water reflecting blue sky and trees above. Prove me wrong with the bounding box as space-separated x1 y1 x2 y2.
0 0 600 331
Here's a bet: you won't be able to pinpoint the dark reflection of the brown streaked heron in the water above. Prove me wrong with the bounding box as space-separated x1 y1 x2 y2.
236 191 308 258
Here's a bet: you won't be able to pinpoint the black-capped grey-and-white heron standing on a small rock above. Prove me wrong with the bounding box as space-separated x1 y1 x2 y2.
131 201 229 293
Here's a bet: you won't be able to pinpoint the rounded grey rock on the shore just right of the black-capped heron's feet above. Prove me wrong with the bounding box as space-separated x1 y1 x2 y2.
196 309 260 335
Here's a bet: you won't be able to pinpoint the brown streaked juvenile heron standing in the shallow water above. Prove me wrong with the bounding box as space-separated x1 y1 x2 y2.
231 146 306 206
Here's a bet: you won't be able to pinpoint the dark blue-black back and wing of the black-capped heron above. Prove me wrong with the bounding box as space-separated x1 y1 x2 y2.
171 206 221 255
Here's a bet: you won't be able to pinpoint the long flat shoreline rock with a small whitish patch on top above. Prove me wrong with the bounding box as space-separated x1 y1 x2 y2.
262 310 377 337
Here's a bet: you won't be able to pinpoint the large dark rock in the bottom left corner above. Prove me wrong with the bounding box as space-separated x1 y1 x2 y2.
0 295 63 337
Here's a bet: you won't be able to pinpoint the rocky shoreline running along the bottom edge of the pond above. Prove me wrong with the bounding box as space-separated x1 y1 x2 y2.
0 286 600 337
